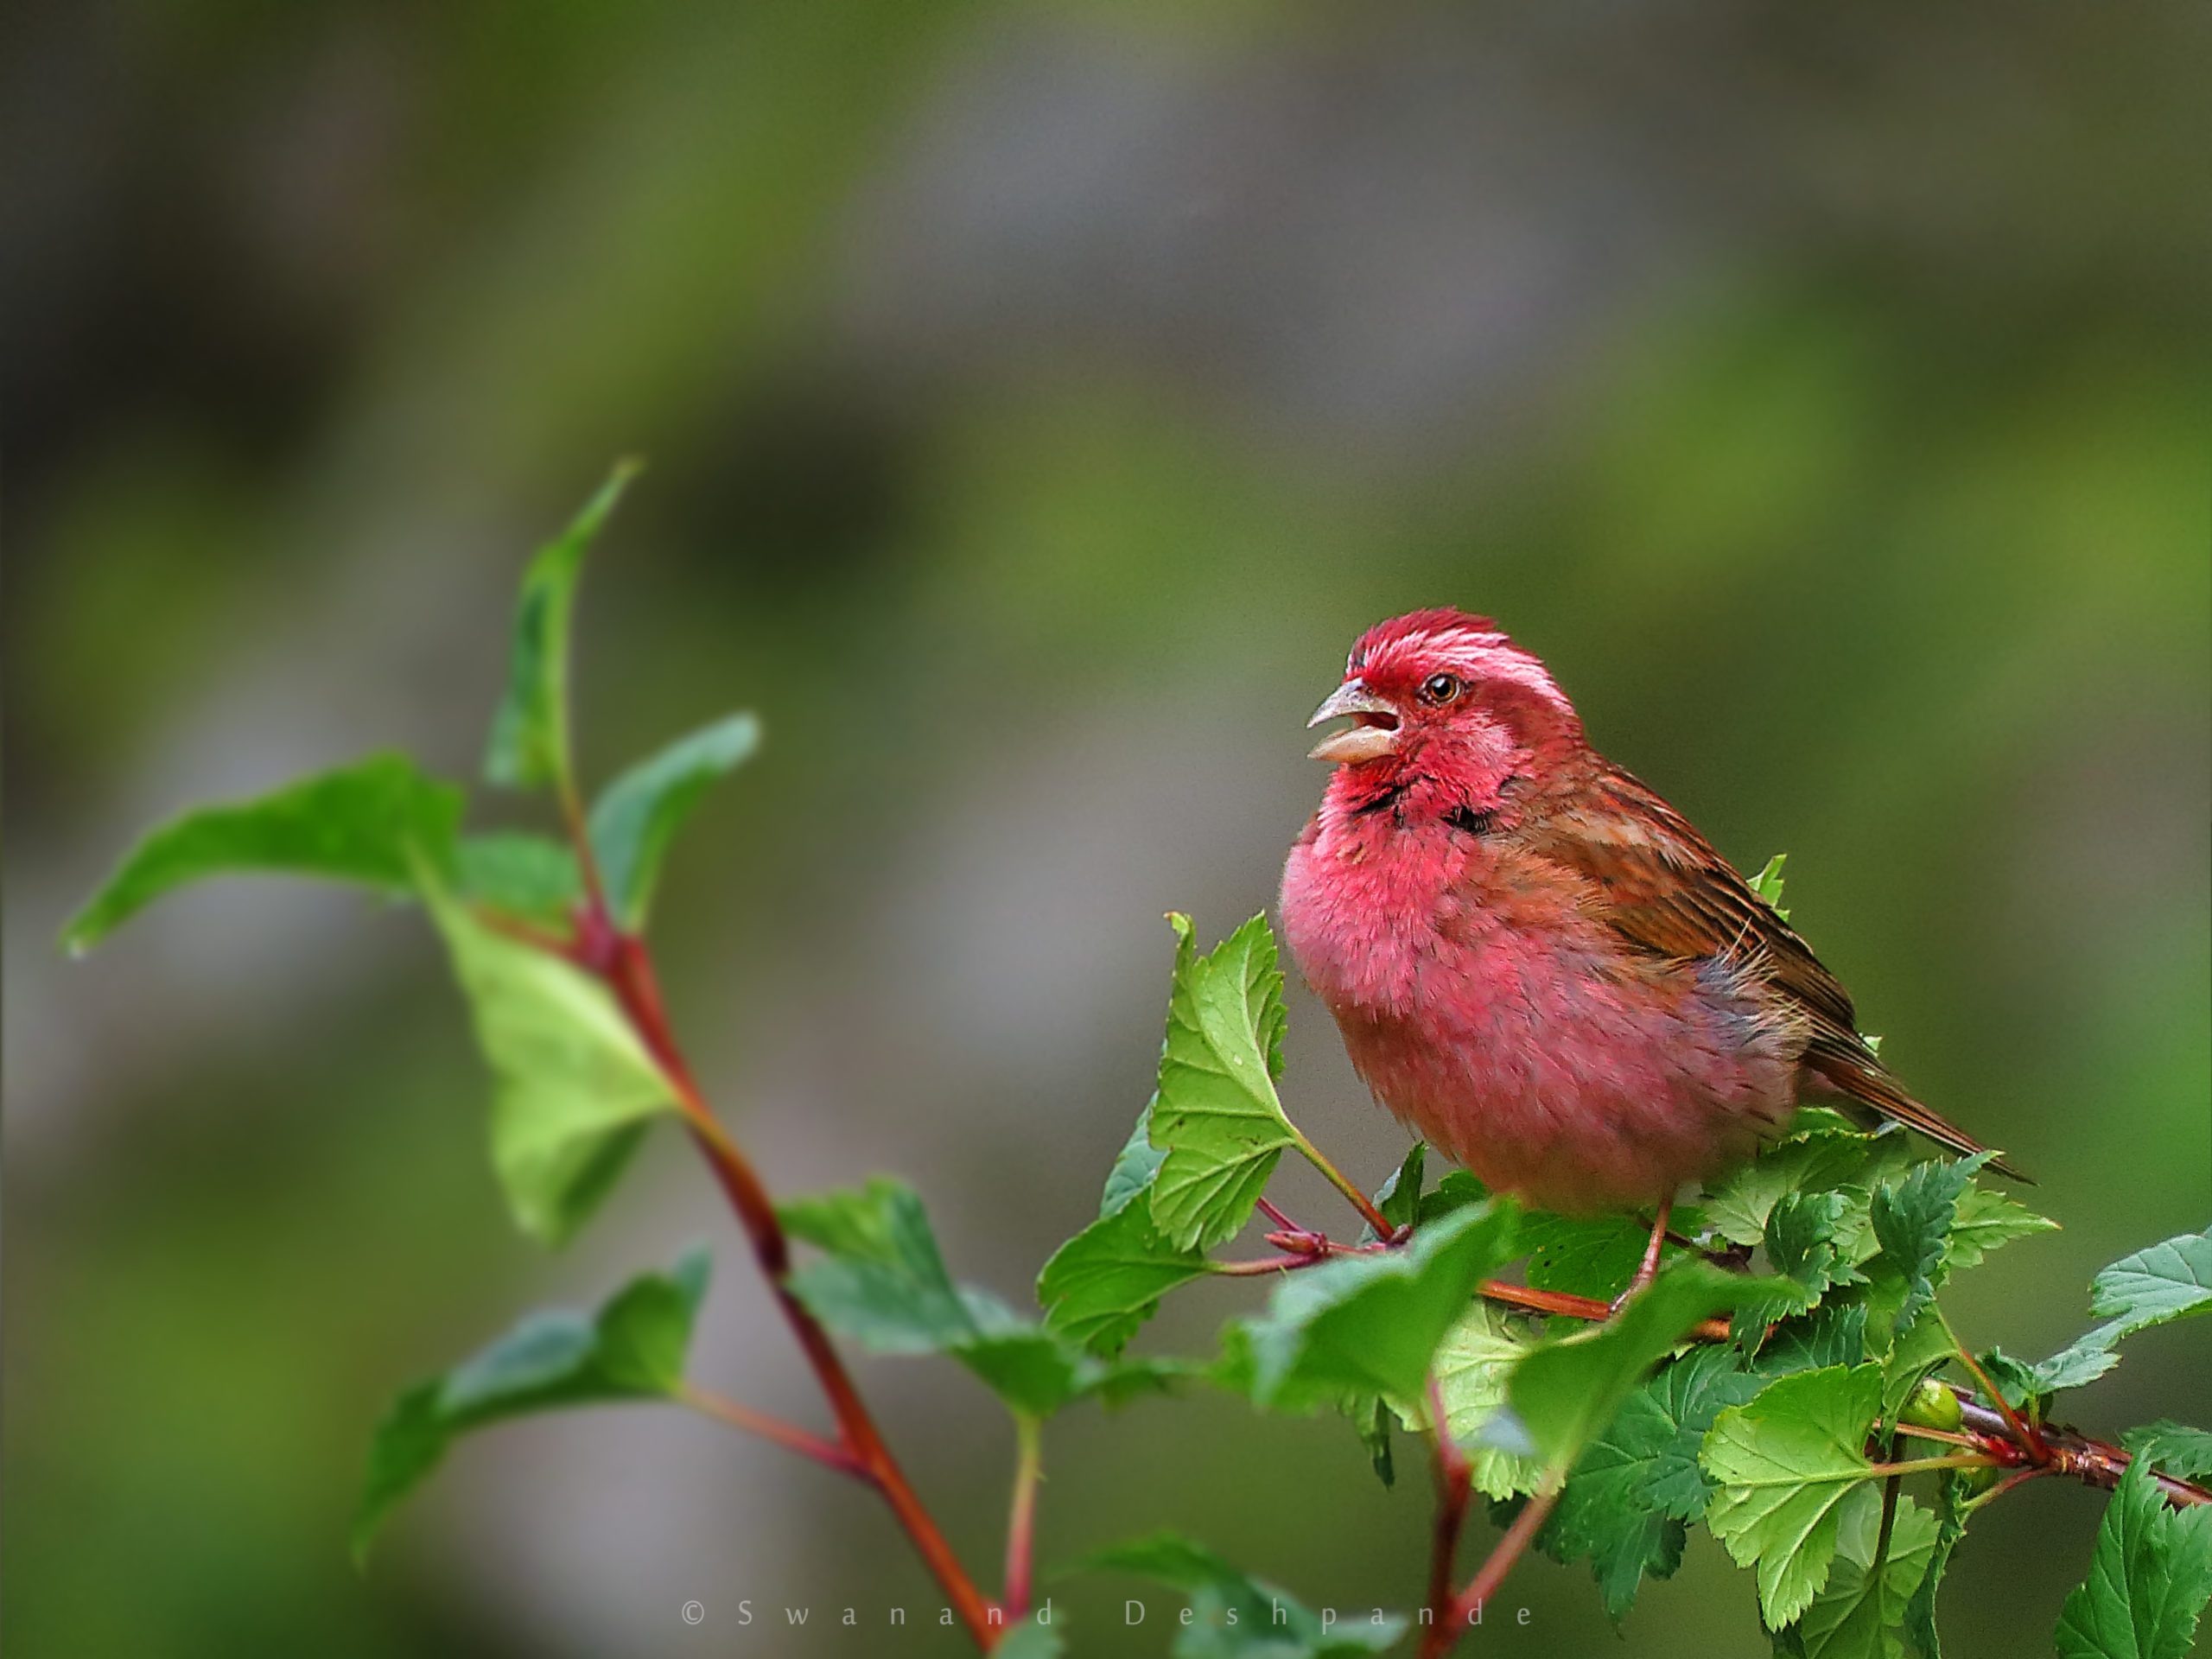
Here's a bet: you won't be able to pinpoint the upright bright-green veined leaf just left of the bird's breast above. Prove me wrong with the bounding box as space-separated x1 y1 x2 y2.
1150 916 1299 1249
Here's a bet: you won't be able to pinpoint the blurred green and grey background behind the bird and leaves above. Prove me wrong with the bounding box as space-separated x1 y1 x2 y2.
0 0 2212 1659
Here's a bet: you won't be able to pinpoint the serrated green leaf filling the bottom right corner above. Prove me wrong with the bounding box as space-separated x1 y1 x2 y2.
2057 1465 2212 1659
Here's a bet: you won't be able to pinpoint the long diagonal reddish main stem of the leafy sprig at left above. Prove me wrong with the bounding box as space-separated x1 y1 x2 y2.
570 915 1004 1652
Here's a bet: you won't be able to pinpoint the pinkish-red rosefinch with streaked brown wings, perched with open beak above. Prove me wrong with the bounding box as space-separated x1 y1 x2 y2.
1283 608 2013 1281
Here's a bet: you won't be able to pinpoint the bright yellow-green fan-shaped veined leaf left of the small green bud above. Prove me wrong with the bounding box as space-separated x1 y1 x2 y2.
1699 1365 1883 1630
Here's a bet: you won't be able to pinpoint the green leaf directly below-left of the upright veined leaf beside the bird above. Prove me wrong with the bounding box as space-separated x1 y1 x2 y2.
1038 1106 1205 1356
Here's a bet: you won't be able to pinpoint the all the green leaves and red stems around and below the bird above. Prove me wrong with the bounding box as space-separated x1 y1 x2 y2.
42 480 2212 1659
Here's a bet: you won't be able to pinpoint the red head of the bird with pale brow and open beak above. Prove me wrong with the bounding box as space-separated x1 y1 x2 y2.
1307 608 1581 817
